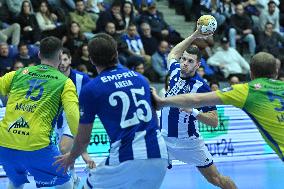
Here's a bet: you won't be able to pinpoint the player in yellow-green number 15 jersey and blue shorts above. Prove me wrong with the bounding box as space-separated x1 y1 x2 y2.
0 37 79 189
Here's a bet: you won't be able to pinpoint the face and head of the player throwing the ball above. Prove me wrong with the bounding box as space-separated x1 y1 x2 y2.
180 52 200 77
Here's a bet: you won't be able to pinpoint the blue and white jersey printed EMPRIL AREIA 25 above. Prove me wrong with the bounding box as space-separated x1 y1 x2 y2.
79 66 168 165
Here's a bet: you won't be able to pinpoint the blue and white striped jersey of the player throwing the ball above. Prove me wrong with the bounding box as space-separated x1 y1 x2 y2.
160 59 216 139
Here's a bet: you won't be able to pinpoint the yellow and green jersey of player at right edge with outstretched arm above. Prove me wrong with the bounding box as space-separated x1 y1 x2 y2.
217 78 284 161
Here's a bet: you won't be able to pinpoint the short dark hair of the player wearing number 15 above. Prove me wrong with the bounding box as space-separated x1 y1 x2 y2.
39 37 62 60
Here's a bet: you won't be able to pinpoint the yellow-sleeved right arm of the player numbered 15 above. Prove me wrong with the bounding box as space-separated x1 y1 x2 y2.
61 79 80 136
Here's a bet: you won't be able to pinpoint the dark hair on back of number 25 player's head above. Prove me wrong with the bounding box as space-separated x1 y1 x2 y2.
88 33 117 68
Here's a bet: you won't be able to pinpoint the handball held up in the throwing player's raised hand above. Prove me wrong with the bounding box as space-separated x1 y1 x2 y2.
197 15 217 34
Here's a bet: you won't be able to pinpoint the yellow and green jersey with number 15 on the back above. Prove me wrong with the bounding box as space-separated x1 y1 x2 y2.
0 65 79 151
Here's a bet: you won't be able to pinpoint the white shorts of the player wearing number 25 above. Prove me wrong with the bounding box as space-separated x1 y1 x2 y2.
84 158 168 189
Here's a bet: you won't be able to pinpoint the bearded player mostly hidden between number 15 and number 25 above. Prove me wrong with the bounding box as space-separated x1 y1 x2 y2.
54 48 96 188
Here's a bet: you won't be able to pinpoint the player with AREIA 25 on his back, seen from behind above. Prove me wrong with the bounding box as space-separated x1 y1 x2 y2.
54 34 168 189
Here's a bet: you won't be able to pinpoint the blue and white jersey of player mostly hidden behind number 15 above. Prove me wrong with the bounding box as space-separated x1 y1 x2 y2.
56 69 90 129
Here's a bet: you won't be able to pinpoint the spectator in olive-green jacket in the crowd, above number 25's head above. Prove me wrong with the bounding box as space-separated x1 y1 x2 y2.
70 0 97 39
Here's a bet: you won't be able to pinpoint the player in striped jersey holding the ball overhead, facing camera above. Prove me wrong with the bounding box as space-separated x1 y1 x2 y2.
160 29 236 189
